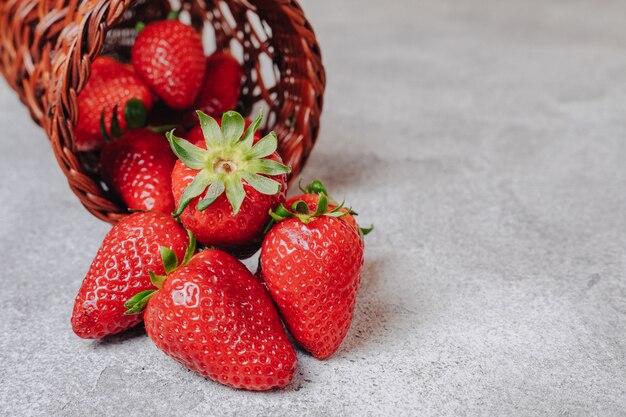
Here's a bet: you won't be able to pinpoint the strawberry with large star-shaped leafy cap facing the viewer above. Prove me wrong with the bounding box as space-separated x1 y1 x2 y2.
167 112 289 257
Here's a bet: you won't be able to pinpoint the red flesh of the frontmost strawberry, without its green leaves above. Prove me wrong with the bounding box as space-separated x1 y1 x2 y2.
145 250 297 391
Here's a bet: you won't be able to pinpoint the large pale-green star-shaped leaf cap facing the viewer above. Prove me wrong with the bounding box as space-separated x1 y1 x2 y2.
166 111 291 217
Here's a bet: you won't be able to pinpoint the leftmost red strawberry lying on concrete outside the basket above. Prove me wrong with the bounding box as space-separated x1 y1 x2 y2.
72 212 193 339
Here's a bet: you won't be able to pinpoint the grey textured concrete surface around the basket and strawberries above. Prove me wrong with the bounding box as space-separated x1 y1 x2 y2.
0 0 626 416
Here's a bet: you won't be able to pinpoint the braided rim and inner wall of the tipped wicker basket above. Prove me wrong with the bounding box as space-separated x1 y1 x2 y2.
43 0 325 223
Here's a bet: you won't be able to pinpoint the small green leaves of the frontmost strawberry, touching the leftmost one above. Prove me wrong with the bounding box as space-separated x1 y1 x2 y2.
124 231 197 316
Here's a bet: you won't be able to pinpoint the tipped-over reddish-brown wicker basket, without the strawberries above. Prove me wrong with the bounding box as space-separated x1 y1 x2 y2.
0 0 325 223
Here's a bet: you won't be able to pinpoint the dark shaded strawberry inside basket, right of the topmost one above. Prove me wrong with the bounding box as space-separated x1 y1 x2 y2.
194 52 243 117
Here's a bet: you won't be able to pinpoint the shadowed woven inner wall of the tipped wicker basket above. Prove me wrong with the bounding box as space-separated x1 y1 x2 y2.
76 0 290 206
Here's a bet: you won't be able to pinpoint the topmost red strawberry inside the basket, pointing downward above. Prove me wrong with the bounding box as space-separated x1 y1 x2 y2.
131 20 206 109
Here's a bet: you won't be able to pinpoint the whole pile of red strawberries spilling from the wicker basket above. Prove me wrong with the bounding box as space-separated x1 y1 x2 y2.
71 12 369 391
